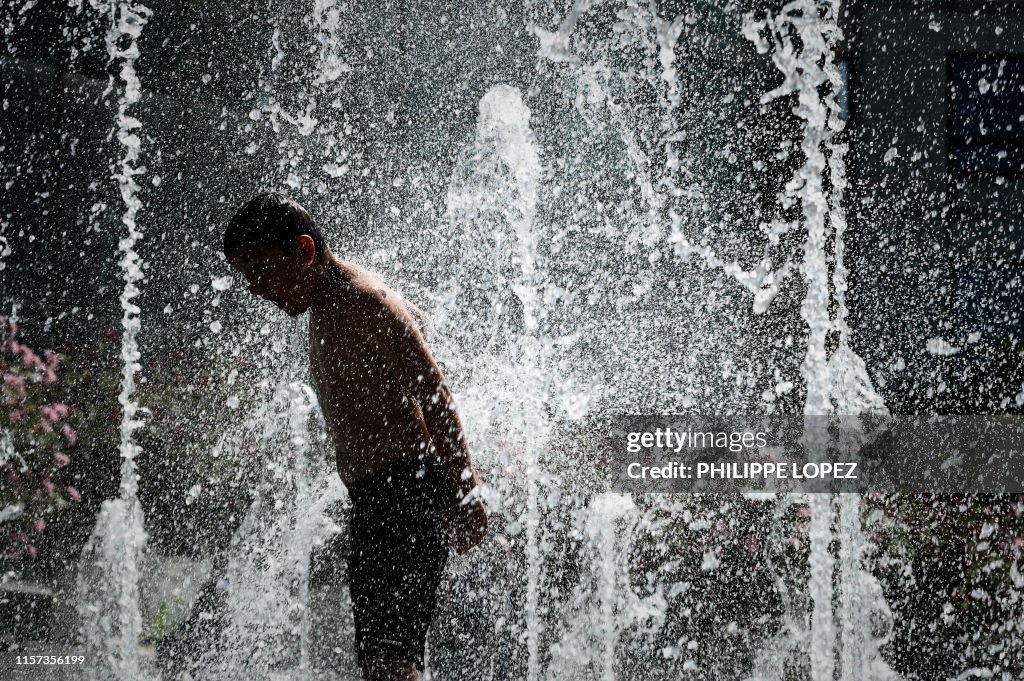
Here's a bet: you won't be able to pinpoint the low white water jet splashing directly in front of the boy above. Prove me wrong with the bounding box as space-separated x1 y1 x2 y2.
195 382 346 681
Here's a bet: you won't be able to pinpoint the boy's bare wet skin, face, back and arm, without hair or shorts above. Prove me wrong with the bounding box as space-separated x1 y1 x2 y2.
228 236 487 553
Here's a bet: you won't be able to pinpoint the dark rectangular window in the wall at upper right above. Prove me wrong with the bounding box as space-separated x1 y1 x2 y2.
947 54 1024 175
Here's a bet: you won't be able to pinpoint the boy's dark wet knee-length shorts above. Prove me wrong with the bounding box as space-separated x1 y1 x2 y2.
348 458 452 672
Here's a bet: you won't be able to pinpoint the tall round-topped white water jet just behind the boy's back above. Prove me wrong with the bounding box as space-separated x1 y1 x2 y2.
447 85 549 681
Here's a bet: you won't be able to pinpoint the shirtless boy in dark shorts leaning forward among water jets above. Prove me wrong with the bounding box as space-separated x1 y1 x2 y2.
224 191 487 680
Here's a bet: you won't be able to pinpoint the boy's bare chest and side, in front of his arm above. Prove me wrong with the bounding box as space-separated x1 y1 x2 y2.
309 264 430 484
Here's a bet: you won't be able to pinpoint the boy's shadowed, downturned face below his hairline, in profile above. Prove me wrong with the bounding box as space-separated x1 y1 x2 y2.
227 244 309 316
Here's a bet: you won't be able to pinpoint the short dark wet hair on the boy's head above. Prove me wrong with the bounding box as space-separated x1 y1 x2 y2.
224 191 326 258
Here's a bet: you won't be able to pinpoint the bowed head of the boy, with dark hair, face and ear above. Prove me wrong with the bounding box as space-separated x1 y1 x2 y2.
224 191 327 316
